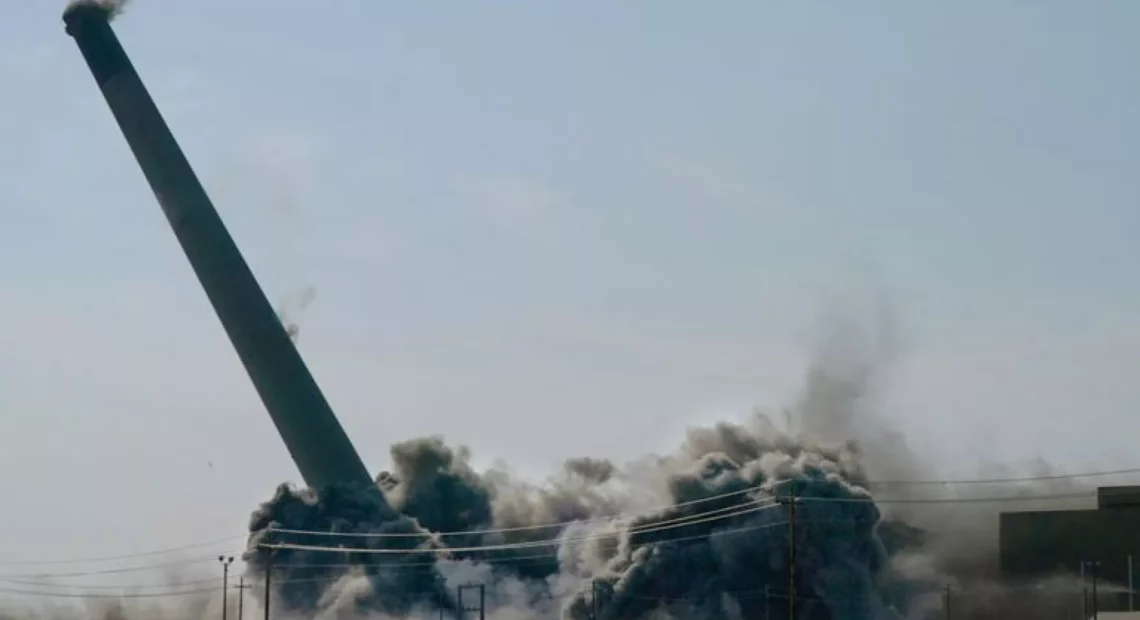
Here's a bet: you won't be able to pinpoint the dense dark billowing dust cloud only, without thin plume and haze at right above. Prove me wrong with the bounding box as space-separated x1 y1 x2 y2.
246 416 890 618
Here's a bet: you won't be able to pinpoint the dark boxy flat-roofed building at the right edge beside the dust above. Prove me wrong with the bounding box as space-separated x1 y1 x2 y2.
999 487 1140 611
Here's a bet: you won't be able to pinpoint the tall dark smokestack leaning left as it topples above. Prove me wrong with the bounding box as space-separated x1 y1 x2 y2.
64 1 372 489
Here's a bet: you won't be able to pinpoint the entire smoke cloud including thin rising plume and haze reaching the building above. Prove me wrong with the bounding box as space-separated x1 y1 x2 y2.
245 310 1103 620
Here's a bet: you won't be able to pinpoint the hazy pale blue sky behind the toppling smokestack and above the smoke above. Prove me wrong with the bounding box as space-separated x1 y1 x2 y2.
0 0 1140 569
